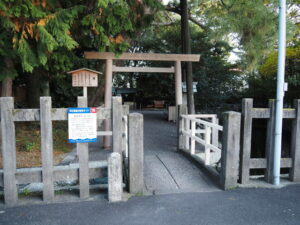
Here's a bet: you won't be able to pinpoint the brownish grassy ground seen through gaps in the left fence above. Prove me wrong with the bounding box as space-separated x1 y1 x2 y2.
0 121 73 168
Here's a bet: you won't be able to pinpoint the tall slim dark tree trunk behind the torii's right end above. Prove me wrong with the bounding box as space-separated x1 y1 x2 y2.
180 0 195 114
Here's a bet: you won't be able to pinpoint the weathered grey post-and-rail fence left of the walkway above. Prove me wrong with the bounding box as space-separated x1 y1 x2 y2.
0 97 131 205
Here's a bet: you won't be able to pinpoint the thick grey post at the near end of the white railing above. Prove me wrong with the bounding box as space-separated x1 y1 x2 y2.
220 112 241 190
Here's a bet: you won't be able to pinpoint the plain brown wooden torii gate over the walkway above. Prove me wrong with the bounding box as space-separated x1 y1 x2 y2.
84 52 200 147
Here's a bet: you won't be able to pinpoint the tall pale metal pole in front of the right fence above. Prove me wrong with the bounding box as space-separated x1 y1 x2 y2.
273 0 286 185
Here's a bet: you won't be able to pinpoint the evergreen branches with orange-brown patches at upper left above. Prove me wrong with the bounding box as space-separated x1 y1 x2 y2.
0 0 160 105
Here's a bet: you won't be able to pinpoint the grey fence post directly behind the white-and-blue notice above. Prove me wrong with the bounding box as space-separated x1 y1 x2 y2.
77 96 90 198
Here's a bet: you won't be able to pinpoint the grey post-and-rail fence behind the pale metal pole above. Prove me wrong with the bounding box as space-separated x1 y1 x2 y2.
240 99 300 184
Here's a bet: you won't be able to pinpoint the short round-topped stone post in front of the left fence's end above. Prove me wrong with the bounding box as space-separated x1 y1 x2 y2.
108 152 123 202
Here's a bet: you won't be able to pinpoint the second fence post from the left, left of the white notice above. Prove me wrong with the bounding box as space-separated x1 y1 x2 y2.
40 97 54 201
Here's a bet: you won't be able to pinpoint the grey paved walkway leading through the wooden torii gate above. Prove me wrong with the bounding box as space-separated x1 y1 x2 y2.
142 111 219 194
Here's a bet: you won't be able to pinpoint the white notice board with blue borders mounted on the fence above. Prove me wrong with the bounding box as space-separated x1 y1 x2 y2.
68 108 97 143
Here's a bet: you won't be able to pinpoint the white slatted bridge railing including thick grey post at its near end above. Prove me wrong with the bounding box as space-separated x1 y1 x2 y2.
178 105 241 189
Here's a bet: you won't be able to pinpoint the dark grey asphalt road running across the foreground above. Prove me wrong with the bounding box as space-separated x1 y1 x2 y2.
0 185 300 225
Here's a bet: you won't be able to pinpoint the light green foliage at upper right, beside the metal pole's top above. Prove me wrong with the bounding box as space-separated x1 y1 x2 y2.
169 0 299 71
